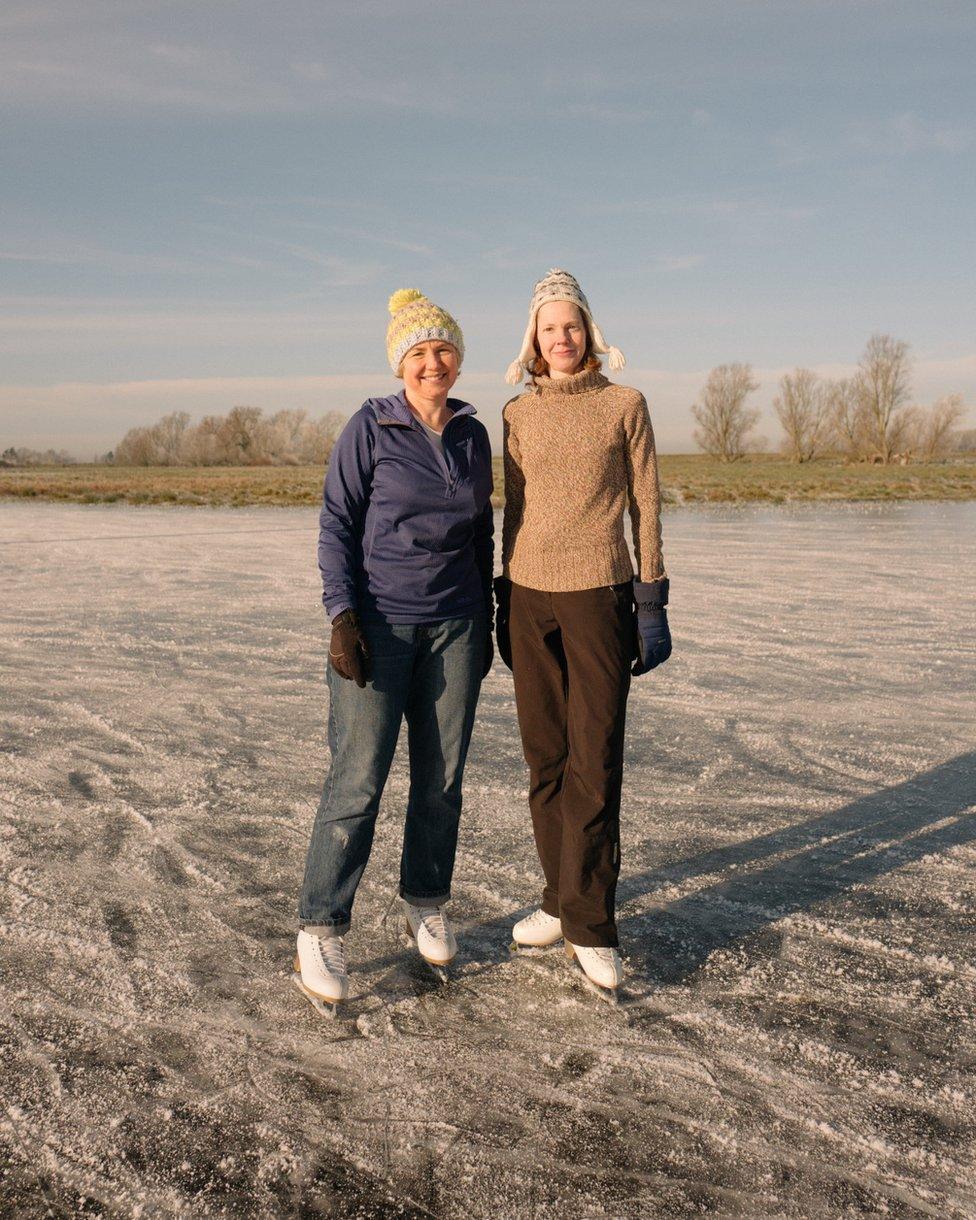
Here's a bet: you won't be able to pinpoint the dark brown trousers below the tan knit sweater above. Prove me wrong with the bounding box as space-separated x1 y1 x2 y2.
510 581 634 947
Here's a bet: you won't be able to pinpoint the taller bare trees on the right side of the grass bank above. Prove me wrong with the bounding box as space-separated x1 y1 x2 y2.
692 334 966 465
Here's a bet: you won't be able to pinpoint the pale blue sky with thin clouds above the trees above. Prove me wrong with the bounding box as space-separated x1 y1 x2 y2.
0 0 976 455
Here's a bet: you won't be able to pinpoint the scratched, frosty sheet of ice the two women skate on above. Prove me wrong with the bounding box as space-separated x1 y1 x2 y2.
0 503 976 1218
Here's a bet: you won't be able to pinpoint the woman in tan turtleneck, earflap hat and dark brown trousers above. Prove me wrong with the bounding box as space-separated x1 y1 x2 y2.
495 270 671 992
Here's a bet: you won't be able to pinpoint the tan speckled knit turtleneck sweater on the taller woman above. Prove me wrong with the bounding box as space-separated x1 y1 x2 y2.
501 361 665 593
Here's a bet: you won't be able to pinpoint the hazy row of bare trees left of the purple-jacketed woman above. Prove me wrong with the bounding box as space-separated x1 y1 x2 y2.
110 406 345 466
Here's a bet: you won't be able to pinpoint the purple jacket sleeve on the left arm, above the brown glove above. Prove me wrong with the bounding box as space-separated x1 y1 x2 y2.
318 411 373 619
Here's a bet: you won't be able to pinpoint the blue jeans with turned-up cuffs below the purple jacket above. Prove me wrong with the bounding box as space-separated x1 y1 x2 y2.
299 614 488 936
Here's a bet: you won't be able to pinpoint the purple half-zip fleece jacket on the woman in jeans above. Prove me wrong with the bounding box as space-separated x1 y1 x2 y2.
318 390 494 623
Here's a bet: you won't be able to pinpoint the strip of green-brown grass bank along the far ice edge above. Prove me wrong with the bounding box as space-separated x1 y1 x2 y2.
0 454 976 508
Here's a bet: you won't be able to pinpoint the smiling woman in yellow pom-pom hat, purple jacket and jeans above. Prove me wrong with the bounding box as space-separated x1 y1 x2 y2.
294 289 493 1010
